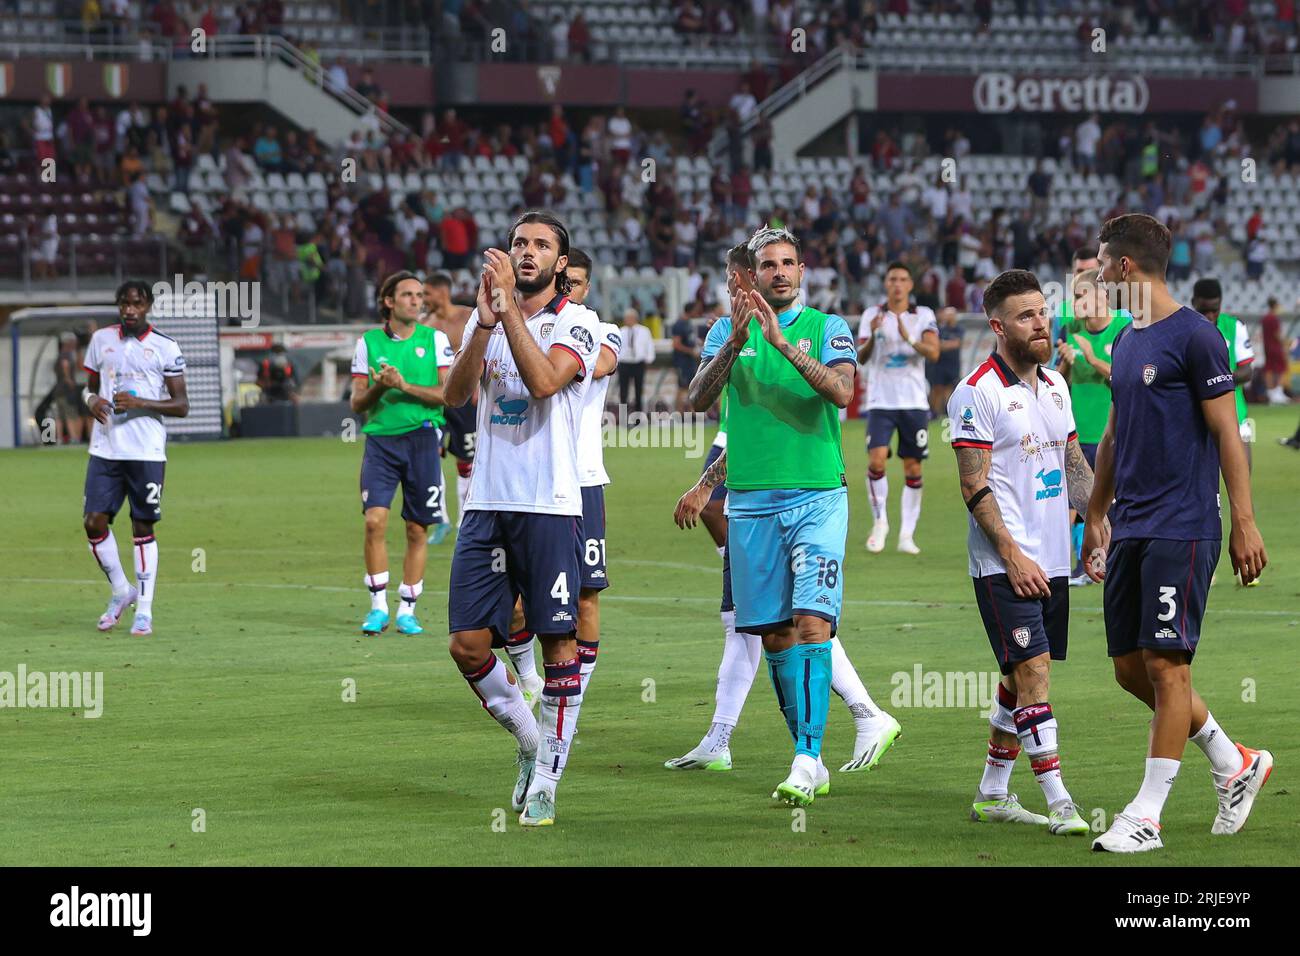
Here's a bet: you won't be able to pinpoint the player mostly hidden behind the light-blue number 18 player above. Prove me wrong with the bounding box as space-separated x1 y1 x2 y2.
664 245 902 773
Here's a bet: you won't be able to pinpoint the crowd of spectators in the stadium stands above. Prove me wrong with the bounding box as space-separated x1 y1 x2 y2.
10 60 1300 316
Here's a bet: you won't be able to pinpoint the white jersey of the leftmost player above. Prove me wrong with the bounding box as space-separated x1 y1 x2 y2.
85 325 185 462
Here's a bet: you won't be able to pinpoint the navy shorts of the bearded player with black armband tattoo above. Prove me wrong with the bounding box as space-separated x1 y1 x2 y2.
971 574 1070 674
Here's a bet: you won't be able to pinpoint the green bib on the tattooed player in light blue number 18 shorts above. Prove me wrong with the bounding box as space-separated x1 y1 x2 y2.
725 307 844 492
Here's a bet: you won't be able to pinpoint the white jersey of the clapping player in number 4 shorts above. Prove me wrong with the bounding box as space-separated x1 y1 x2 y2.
460 295 601 515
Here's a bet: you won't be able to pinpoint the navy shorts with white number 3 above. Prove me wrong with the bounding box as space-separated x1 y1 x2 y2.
1101 537 1222 661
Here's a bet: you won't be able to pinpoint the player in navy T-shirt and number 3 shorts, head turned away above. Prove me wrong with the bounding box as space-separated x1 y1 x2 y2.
1084 215 1273 853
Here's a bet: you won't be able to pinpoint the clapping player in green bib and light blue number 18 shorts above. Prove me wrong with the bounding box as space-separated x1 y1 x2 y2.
690 228 873 806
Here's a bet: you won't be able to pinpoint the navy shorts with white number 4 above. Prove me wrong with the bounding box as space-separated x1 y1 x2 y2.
447 511 585 640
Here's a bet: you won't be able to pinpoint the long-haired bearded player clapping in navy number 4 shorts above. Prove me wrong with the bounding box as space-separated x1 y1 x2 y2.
447 212 601 826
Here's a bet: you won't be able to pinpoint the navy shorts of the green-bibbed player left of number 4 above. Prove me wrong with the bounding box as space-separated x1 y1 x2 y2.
361 425 447 527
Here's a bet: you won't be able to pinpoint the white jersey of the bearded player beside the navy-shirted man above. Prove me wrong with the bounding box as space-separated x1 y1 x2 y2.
948 352 1076 578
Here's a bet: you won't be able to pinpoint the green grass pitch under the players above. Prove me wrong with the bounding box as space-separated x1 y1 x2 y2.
0 408 1300 866
